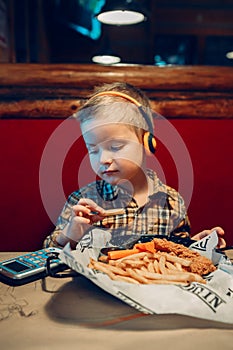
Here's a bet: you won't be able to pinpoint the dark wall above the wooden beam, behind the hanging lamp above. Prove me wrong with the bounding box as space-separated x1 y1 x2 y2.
5 0 233 66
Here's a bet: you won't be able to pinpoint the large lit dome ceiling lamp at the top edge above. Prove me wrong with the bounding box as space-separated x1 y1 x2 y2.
96 0 146 26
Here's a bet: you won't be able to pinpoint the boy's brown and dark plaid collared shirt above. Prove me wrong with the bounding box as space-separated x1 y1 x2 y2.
44 169 190 247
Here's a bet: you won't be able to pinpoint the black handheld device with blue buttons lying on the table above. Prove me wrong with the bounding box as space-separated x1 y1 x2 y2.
0 247 68 286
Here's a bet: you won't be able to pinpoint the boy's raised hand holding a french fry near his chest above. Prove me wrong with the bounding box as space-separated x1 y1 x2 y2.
63 198 105 242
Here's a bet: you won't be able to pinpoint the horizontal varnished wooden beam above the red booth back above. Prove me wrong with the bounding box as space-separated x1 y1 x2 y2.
0 64 233 119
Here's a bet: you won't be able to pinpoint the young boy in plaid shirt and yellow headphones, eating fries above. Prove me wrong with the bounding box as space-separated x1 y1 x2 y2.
44 83 225 249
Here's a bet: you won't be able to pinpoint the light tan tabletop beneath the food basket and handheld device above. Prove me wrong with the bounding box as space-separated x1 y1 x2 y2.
0 252 233 350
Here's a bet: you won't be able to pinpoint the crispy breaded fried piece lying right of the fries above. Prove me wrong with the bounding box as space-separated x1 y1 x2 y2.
153 238 216 276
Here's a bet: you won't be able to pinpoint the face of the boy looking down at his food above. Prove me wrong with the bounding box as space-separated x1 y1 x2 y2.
83 121 144 185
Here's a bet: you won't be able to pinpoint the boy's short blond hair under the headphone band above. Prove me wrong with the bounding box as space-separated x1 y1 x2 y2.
76 82 153 136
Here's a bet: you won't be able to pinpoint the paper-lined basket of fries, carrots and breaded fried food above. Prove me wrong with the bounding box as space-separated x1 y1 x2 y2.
60 230 233 324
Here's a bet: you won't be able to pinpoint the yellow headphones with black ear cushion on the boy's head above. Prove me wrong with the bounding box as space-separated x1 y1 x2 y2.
92 91 156 154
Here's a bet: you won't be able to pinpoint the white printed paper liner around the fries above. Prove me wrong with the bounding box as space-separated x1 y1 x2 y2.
59 229 233 324
